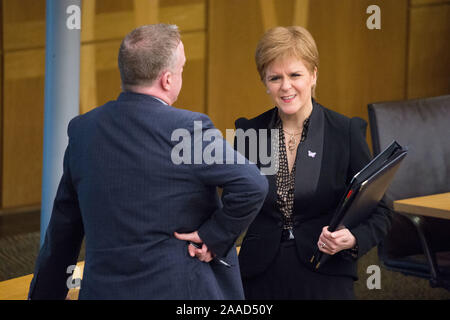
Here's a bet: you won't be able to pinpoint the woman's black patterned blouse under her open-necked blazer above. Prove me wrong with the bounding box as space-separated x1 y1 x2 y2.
275 117 309 230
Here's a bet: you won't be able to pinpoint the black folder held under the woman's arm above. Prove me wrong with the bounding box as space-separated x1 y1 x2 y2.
311 141 407 269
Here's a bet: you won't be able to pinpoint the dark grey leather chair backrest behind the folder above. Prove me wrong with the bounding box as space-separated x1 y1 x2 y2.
368 95 450 204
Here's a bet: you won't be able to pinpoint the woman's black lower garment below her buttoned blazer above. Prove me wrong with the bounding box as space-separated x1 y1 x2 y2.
243 240 355 300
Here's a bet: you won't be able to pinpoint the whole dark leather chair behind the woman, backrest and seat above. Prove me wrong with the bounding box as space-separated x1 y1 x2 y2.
368 95 450 290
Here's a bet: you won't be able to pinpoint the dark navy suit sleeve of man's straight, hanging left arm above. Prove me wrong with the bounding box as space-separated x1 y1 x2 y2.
28 124 84 299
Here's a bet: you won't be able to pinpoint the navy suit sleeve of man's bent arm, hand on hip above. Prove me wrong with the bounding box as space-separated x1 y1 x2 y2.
193 115 268 257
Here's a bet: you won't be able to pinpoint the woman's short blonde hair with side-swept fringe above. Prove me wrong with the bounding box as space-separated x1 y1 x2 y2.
255 26 319 95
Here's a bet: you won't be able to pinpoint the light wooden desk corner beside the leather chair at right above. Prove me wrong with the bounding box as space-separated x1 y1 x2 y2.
394 192 450 220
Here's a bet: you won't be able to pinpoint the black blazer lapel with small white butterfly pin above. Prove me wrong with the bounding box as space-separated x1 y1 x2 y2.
294 102 325 213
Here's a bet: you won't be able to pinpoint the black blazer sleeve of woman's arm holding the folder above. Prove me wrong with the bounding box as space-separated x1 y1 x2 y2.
348 118 391 258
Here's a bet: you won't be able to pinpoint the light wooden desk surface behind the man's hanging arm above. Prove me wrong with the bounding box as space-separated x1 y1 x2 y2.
0 262 84 300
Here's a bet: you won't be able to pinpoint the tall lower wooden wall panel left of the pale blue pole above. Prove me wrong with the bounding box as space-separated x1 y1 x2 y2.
2 49 45 208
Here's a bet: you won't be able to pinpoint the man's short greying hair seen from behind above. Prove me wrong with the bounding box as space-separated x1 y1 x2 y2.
118 23 181 89
